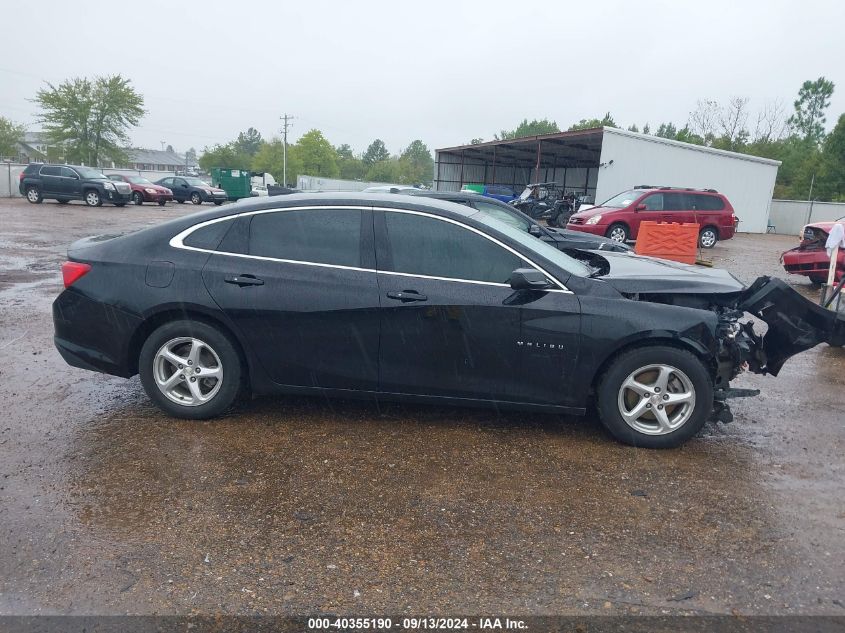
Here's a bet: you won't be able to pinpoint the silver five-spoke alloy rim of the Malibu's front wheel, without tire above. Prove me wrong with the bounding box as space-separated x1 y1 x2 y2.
618 365 695 435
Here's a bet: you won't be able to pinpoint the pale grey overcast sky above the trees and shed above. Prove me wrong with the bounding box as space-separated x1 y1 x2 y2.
0 0 845 153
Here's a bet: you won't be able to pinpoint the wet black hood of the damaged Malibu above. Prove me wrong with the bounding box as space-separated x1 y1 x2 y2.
599 251 745 294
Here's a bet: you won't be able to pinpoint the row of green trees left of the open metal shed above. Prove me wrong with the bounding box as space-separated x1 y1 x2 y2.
199 127 434 186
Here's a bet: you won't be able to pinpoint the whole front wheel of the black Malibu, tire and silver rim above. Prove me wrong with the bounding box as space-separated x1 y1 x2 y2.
596 345 713 448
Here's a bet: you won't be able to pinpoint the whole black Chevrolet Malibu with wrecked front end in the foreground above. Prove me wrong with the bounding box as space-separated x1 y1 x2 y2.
53 193 845 447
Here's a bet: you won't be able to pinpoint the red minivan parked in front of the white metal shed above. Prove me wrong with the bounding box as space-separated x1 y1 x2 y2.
566 186 737 248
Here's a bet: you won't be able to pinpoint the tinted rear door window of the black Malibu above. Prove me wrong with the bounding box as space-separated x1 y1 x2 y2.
249 209 362 267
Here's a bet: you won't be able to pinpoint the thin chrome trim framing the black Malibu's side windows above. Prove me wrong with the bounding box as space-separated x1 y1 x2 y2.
168 205 573 294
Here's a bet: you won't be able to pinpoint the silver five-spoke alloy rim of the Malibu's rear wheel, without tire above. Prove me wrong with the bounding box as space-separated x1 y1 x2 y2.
153 336 223 407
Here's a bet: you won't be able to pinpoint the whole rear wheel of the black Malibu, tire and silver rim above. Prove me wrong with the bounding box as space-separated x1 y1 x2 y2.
138 320 243 420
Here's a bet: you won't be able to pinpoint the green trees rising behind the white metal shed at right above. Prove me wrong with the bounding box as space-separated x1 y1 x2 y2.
478 77 845 201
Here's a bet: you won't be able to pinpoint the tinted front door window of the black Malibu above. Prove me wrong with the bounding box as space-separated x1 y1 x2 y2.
385 212 526 283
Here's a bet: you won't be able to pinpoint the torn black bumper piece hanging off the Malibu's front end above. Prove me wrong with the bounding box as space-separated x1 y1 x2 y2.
737 277 845 376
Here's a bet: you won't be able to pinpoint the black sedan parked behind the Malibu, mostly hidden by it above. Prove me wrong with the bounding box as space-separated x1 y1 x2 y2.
401 189 632 253
